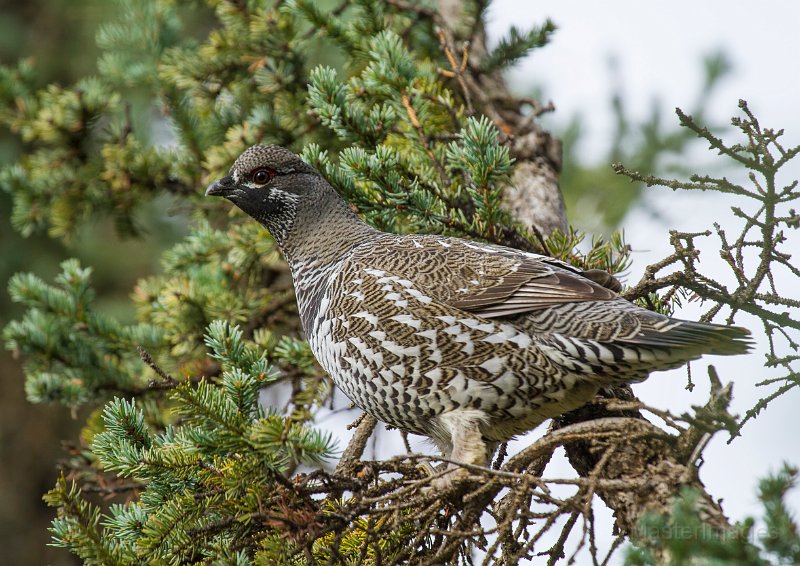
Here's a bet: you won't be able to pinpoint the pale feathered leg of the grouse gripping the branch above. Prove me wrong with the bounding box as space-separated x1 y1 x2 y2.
433 411 489 489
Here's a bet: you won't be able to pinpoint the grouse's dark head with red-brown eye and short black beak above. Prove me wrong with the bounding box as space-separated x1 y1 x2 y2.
206 145 329 239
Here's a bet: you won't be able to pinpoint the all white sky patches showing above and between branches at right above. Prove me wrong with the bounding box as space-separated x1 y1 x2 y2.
472 0 800 563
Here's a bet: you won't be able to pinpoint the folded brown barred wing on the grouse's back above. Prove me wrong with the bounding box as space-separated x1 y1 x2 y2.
358 236 618 318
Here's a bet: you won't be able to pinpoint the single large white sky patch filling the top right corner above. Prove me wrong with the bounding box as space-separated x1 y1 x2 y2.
489 0 800 169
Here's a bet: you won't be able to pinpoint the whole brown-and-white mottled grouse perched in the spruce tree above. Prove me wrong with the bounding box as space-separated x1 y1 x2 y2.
206 145 750 485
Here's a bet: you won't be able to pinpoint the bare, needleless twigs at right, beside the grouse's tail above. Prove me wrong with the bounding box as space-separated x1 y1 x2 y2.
614 101 800 436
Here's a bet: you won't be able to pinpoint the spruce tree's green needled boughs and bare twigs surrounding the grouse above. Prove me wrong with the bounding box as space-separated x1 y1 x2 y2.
0 0 800 564
